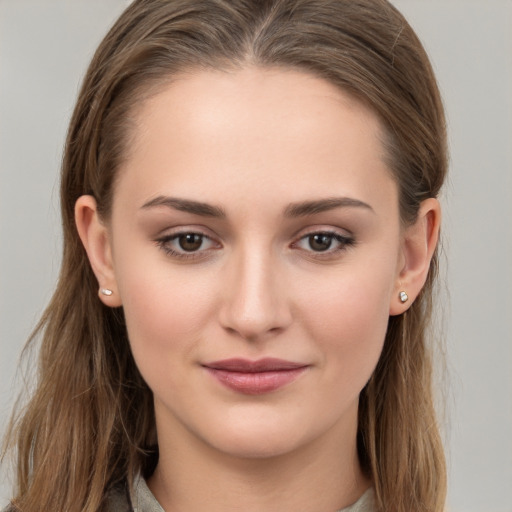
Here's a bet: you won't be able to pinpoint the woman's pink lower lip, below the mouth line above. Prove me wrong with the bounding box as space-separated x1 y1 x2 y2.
206 366 307 395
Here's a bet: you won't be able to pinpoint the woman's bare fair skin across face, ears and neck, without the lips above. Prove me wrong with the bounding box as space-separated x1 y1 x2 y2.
76 67 440 511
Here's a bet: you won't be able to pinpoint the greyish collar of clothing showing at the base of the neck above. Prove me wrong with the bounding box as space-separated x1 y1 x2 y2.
108 477 375 512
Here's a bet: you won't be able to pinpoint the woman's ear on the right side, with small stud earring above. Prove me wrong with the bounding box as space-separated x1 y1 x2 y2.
389 198 441 315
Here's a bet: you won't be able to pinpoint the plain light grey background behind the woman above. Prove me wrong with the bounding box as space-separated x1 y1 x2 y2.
0 0 512 512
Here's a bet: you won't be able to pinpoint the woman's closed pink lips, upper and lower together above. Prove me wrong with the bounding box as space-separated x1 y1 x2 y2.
203 358 309 395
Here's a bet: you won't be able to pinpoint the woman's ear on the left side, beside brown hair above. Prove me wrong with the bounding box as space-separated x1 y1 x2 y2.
75 195 122 307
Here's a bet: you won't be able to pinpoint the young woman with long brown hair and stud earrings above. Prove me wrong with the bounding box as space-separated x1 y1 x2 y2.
2 0 446 512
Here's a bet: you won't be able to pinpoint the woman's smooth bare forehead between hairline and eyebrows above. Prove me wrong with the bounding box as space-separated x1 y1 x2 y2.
115 68 392 214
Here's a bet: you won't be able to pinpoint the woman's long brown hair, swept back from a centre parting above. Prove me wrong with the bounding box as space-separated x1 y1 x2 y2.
2 0 447 512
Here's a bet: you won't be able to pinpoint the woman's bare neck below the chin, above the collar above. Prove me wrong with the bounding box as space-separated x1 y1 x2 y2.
148 414 370 512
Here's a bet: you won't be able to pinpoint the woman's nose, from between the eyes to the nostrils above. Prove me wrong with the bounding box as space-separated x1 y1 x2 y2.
220 246 292 341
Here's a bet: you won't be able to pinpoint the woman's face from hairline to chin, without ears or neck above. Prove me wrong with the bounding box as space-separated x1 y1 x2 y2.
110 69 401 457
